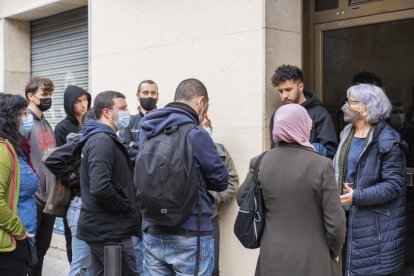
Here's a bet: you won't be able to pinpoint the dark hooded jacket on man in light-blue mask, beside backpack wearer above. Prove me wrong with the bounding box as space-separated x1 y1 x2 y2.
75 121 140 242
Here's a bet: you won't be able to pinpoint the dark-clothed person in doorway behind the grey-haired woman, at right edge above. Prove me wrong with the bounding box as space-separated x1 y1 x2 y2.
389 102 414 168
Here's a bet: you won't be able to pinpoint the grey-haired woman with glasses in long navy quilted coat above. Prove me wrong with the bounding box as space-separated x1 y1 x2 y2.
334 84 407 275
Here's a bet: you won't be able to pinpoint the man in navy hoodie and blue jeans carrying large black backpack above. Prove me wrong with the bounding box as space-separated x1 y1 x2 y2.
135 79 228 275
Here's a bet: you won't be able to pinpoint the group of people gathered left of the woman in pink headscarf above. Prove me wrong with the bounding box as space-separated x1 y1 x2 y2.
0 77 239 275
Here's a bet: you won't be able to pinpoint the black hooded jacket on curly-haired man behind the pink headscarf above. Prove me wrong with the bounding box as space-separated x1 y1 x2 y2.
269 90 338 159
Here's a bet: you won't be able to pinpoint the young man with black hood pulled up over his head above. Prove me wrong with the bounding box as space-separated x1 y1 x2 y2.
54 85 91 263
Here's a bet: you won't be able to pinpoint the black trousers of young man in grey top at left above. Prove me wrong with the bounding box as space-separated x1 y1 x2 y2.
28 205 55 276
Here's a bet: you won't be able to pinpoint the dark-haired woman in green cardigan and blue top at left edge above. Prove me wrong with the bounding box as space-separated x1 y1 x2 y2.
0 93 38 276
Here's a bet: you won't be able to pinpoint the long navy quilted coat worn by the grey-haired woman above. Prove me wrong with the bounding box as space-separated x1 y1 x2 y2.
334 122 407 275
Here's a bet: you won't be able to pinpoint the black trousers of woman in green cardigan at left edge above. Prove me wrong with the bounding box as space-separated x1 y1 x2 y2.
0 240 28 276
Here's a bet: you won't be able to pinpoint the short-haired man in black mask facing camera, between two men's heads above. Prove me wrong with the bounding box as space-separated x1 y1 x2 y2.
118 80 159 166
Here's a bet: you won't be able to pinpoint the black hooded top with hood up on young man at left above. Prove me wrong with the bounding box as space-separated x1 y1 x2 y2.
54 85 91 147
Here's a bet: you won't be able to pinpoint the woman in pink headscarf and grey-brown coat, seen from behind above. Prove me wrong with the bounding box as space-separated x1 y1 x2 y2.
237 104 346 276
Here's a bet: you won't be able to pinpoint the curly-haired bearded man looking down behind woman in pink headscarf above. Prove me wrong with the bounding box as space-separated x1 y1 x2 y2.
269 65 338 159
